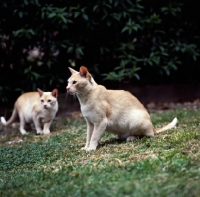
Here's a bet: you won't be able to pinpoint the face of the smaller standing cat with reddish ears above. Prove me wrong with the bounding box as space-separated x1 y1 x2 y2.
38 88 58 109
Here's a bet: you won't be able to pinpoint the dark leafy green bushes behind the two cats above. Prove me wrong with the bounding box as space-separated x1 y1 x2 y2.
0 0 200 105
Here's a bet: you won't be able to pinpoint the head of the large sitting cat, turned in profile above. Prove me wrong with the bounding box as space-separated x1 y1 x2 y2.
66 68 91 95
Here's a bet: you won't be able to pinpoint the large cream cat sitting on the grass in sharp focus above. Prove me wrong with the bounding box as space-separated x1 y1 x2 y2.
66 66 177 151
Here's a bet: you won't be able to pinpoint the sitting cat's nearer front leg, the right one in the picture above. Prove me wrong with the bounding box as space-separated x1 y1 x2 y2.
86 119 107 151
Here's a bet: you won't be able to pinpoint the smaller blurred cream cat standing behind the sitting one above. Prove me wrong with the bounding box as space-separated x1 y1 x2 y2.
1 88 58 135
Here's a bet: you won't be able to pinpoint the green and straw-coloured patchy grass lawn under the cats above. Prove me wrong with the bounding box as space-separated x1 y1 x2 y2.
0 109 200 197
